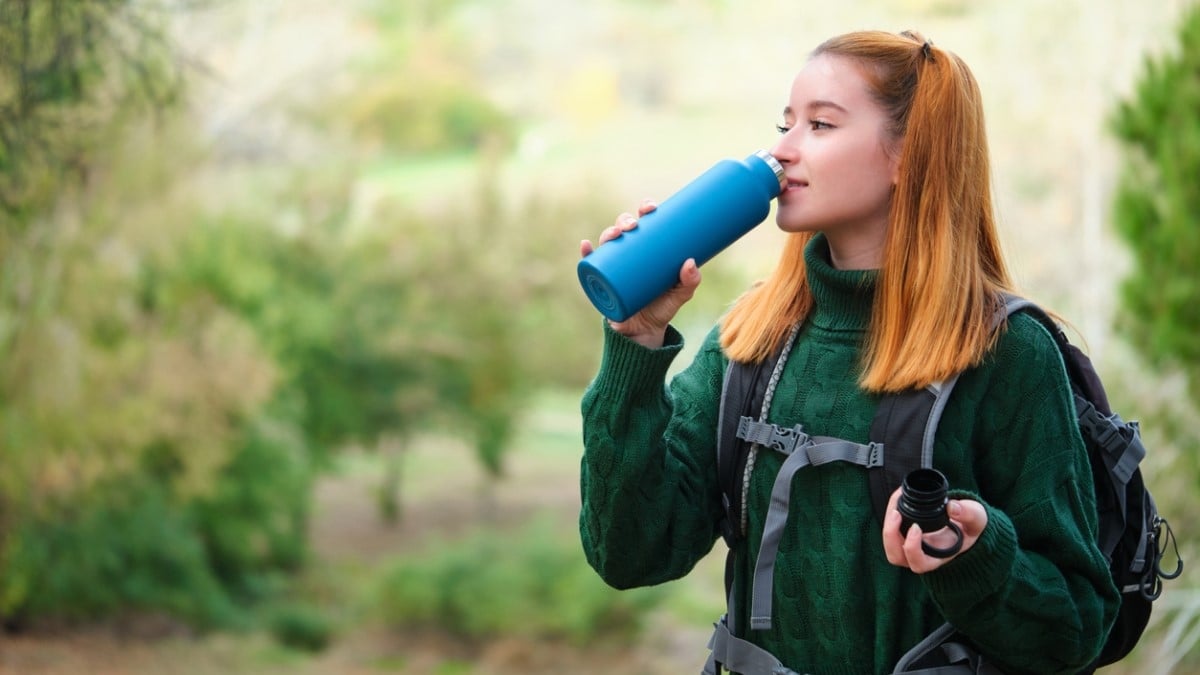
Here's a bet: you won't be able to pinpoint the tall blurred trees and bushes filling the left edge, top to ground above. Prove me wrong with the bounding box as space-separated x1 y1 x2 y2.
0 0 308 625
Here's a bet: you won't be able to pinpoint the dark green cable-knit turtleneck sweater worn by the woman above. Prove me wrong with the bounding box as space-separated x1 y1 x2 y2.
580 237 1118 675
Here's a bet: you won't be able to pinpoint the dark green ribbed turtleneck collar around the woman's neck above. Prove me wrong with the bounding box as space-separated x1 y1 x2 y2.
804 233 878 330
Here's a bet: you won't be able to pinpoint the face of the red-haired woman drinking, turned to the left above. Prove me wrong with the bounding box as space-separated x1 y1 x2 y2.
772 54 899 252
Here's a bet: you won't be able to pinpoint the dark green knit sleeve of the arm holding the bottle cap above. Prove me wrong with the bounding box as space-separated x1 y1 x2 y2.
925 315 1120 673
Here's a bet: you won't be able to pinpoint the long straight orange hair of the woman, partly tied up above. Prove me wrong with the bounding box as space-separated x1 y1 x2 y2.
721 31 1012 393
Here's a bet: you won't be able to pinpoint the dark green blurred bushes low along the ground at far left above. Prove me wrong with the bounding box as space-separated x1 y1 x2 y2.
0 415 311 628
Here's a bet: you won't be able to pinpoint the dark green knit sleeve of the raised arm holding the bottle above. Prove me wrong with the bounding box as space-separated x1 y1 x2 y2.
580 322 725 589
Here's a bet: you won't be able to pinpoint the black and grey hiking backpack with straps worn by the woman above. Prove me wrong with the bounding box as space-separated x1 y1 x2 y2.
706 295 1183 673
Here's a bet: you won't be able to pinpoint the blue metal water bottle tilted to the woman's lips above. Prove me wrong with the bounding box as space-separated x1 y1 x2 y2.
576 150 786 321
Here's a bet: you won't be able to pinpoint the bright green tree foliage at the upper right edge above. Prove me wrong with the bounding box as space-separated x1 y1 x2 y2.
1112 6 1200 400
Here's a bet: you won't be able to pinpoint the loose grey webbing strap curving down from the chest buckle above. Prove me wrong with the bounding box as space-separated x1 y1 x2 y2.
750 435 883 631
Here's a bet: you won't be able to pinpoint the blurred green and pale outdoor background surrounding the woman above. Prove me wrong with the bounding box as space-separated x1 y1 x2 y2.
0 0 1200 675
